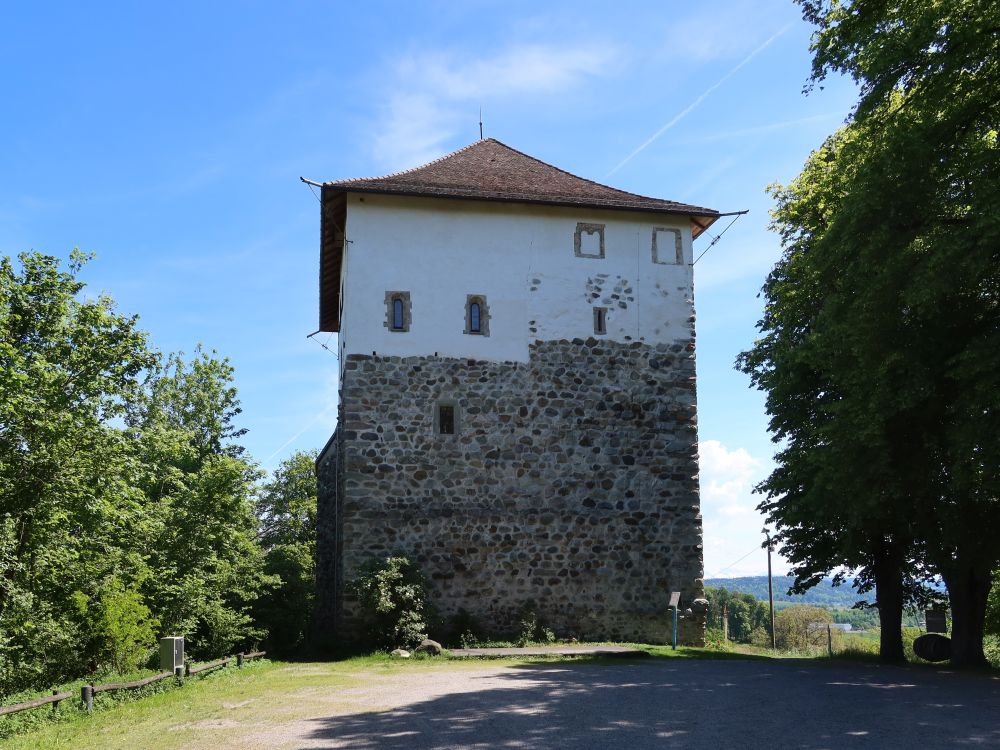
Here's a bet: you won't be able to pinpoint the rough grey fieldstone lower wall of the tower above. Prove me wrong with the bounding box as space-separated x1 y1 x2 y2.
318 338 704 644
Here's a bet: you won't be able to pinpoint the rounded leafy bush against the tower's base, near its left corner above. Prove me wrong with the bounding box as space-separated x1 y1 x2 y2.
348 555 430 649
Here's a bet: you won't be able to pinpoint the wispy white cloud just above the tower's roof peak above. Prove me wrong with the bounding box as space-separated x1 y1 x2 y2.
372 44 615 171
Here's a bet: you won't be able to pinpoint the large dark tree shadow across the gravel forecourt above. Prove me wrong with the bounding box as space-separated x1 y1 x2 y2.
307 660 1000 750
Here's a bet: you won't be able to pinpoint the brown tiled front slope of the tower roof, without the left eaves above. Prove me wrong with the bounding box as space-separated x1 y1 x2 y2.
324 138 719 223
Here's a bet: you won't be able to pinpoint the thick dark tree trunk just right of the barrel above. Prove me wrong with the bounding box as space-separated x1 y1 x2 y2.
942 558 992 667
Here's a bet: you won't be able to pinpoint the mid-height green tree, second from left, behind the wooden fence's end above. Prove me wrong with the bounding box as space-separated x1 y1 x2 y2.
129 348 276 658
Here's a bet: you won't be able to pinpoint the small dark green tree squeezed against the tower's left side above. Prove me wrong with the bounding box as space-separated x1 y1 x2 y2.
255 451 317 654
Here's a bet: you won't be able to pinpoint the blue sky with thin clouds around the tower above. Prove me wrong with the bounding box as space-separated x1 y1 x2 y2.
0 0 855 576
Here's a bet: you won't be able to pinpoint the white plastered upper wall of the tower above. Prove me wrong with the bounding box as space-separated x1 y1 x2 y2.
340 194 693 362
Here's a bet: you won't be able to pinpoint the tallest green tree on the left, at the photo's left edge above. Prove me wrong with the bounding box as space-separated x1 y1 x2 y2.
0 251 156 692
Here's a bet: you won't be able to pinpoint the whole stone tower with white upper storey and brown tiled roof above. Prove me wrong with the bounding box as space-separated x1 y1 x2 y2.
317 139 719 643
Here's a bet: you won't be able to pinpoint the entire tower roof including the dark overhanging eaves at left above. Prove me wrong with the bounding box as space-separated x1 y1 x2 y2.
319 138 722 332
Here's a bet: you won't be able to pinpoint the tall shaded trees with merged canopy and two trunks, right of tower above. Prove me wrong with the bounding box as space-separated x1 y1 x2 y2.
738 0 1000 665
